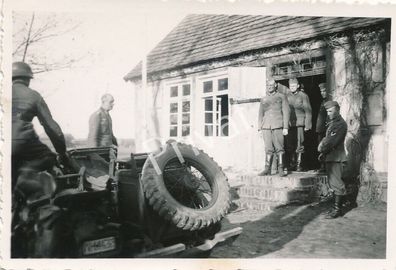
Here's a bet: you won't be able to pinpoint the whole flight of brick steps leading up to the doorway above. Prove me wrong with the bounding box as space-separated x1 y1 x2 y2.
230 172 327 211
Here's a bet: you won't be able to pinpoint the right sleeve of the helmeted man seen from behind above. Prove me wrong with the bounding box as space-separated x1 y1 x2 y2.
37 97 66 154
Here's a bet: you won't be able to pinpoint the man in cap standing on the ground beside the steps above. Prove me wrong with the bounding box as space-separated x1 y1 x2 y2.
318 101 347 218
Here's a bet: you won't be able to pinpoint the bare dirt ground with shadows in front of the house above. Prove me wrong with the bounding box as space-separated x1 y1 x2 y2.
211 202 387 259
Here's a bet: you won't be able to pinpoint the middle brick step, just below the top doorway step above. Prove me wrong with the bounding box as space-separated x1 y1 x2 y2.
236 185 316 203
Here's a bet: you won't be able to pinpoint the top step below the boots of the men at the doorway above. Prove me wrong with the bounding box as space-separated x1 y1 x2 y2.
232 173 327 189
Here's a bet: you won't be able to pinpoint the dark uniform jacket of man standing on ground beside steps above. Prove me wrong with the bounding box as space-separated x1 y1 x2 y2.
318 115 348 162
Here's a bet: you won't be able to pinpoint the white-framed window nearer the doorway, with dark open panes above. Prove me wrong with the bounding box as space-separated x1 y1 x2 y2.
202 78 229 137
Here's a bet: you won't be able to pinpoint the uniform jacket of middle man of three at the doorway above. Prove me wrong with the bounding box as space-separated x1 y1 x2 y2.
287 91 312 129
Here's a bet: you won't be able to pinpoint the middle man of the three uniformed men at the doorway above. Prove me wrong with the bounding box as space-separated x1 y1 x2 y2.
286 78 312 171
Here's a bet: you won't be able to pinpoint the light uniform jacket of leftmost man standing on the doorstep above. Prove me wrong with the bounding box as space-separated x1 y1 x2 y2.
258 92 289 129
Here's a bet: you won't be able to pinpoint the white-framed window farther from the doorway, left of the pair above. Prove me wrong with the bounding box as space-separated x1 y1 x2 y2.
169 84 191 137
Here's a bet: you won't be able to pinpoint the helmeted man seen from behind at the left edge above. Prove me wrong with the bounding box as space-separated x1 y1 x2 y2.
12 62 66 188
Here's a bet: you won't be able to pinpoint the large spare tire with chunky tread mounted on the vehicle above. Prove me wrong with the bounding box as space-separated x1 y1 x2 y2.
142 142 231 231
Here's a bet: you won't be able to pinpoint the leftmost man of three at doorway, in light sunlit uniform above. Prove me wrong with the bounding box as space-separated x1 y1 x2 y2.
258 79 289 176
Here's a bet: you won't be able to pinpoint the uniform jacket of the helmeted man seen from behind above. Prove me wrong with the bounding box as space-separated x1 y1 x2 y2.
12 80 66 154
